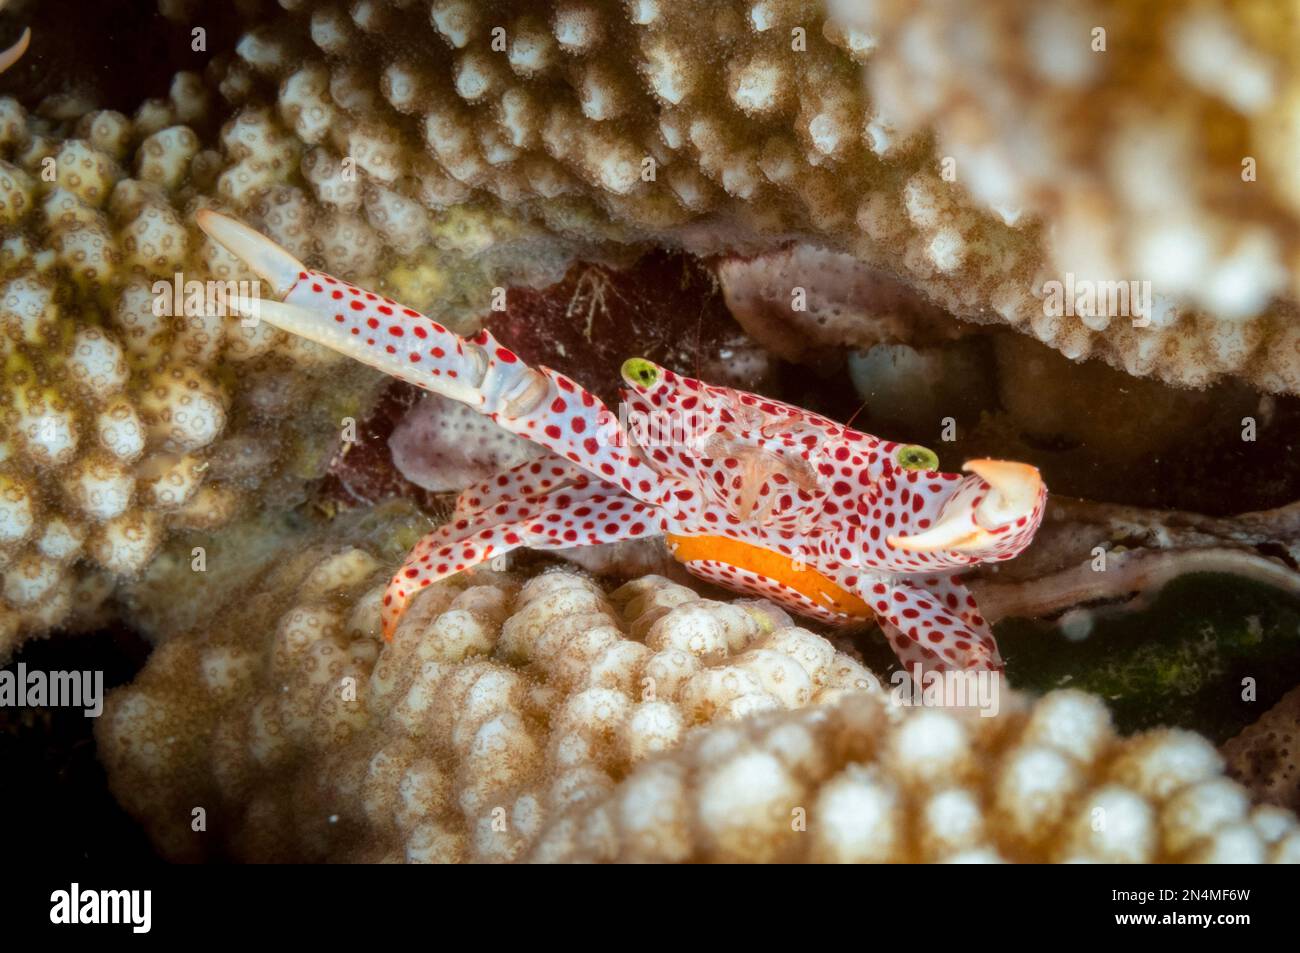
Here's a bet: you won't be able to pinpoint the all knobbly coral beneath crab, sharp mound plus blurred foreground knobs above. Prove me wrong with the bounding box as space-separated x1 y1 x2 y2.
98 515 1300 862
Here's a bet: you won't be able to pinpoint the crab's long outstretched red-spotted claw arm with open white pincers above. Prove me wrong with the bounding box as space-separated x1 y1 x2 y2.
196 209 696 506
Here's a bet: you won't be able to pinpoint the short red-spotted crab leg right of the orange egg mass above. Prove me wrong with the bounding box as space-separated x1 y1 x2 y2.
867 576 1002 671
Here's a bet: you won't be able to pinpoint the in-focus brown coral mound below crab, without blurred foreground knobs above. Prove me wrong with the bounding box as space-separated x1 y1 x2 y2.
96 511 879 861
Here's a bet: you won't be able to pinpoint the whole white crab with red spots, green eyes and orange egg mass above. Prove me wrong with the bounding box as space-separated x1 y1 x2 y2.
198 211 1047 668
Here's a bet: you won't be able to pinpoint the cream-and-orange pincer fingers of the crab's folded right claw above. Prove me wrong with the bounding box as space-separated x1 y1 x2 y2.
887 460 1043 553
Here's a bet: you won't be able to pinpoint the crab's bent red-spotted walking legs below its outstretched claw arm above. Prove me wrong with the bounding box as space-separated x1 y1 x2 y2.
381 468 663 640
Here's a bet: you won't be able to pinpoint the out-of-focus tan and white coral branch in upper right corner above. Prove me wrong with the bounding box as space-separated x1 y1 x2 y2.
842 0 1300 364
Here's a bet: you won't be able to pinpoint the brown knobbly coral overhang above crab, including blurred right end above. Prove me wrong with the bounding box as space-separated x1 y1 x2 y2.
178 0 1300 393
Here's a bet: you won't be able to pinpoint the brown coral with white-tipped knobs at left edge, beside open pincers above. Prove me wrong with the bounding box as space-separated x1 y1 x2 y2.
0 83 387 659
